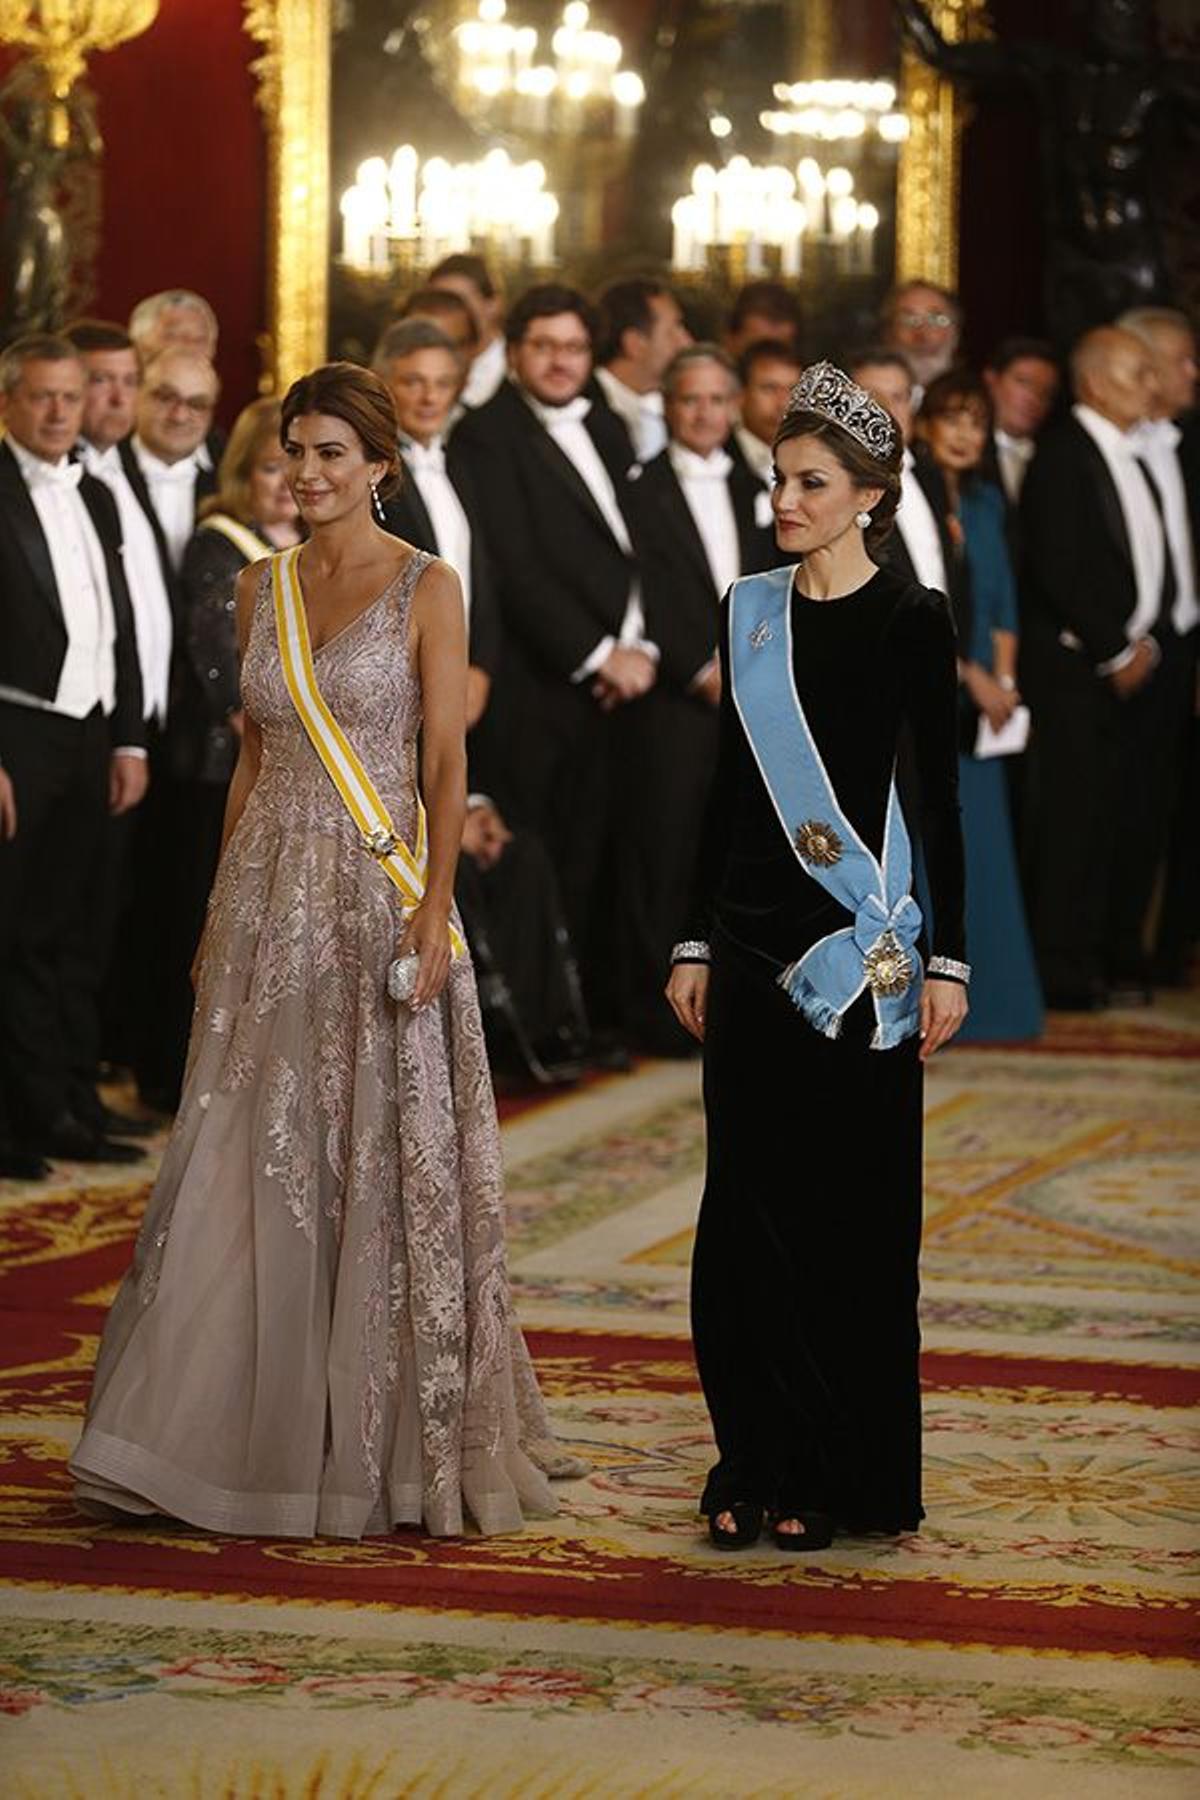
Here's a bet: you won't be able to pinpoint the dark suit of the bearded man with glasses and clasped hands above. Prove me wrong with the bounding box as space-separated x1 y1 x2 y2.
453 382 637 997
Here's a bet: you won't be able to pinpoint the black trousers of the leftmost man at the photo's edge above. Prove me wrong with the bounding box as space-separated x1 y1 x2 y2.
0 702 112 1141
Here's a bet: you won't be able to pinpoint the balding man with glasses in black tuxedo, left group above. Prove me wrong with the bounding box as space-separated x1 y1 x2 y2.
112 344 219 1112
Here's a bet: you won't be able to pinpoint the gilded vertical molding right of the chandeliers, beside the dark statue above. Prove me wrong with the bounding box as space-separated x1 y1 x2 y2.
896 0 990 288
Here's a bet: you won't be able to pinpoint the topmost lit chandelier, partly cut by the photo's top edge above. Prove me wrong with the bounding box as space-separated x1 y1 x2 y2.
453 0 646 137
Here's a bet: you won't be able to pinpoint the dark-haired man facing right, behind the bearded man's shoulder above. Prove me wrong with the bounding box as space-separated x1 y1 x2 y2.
596 279 691 463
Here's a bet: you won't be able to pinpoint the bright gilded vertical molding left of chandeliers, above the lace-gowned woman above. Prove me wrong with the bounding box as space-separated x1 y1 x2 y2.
245 0 331 392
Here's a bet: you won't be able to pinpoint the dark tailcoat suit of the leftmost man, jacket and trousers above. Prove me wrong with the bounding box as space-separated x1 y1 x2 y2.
0 445 146 1141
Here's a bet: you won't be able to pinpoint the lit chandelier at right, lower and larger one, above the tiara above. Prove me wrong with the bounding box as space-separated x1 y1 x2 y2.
671 157 880 279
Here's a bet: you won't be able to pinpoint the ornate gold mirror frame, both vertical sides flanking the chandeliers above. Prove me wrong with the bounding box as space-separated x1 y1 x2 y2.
245 0 988 372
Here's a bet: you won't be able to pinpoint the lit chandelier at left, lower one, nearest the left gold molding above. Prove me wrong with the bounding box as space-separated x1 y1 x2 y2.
340 144 558 274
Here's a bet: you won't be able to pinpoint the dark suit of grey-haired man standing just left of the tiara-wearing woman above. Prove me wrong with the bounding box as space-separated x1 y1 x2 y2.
617 450 781 1049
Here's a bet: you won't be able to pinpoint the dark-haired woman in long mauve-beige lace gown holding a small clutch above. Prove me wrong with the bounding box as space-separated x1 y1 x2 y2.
70 364 579 1537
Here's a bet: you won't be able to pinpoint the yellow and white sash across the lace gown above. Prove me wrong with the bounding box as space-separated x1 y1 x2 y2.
272 544 466 956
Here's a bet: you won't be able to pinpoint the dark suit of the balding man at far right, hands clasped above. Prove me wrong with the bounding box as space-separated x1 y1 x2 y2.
1022 418 1187 1003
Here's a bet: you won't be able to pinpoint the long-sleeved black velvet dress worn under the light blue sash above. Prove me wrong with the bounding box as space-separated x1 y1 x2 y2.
689 571 964 1530
